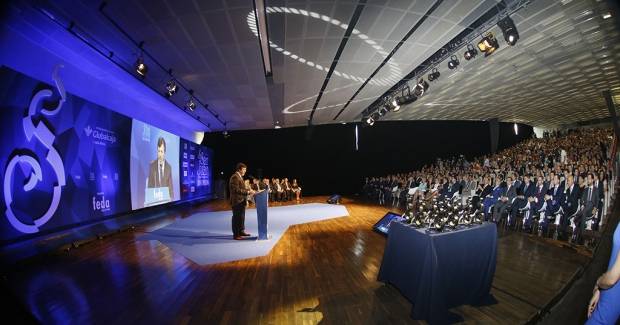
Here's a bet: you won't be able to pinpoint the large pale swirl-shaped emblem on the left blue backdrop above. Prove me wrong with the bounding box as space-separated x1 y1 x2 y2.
4 64 67 234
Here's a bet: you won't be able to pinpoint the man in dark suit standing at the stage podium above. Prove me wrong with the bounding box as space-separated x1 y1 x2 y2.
228 163 256 240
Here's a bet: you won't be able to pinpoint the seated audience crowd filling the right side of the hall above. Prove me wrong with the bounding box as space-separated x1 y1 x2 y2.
363 129 617 244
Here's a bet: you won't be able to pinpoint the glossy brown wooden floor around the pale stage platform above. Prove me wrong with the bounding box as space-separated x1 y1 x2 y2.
3 197 590 325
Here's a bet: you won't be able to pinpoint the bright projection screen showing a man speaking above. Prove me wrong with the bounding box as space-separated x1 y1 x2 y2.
130 120 181 210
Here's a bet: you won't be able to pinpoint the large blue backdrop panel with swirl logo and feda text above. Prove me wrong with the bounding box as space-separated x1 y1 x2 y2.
0 67 131 242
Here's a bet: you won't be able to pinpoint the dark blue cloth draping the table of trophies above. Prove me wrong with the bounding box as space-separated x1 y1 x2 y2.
378 223 497 323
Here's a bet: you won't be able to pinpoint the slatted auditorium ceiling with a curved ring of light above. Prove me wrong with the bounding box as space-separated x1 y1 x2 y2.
37 0 620 131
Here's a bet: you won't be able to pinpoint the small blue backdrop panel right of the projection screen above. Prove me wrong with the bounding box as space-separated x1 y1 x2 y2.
180 139 213 200
